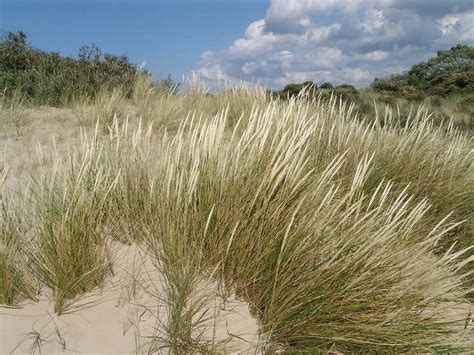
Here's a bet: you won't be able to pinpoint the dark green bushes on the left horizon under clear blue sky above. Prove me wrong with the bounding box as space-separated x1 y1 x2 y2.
0 31 139 105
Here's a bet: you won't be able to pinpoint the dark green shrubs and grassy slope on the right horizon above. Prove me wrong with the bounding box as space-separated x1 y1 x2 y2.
271 45 474 134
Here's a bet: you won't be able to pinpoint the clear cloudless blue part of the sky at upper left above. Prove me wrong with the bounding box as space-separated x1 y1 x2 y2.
0 0 268 80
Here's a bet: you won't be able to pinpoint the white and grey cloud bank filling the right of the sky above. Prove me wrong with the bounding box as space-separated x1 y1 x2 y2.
196 0 474 88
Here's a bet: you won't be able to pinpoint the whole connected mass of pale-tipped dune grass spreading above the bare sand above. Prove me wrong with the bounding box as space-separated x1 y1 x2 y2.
0 83 474 353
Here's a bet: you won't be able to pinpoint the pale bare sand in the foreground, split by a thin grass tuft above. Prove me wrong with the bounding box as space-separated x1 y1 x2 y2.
0 243 258 354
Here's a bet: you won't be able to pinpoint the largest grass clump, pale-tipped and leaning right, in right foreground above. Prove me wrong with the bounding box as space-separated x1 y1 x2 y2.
143 100 472 352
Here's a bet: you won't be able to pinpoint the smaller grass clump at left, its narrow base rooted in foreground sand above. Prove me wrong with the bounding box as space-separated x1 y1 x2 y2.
30 133 114 313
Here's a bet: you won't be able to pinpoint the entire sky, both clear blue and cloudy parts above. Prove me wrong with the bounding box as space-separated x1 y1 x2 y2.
0 0 474 89
